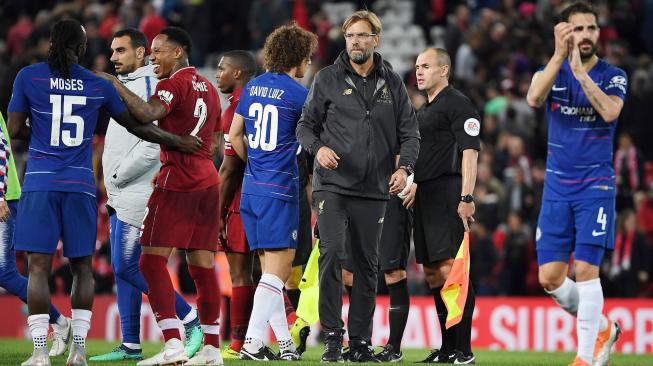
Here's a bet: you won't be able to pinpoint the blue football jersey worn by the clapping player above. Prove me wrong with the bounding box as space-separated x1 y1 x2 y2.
544 60 628 200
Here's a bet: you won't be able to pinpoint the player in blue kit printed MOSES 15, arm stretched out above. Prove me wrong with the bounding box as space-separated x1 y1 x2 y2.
8 20 201 365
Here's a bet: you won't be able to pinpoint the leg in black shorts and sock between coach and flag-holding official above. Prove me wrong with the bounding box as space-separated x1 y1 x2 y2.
376 197 412 362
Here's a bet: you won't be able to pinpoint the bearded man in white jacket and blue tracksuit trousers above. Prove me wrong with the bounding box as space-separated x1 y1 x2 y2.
90 29 203 361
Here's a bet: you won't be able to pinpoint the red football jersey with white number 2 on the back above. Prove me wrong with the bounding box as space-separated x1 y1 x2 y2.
152 66 220 192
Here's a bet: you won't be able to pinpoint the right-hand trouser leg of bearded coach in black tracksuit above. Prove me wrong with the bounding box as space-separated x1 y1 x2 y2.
347 198 386 362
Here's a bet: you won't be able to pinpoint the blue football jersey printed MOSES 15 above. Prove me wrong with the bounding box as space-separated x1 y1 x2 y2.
8 63 126 196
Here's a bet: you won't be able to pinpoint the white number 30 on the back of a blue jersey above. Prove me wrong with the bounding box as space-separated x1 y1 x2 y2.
247 103 279 151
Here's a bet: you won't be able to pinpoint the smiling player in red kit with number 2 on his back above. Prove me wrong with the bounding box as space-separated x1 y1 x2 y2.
97 27 223 365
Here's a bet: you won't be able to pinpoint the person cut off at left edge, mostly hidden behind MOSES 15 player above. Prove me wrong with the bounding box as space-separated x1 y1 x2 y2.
0 114 71 357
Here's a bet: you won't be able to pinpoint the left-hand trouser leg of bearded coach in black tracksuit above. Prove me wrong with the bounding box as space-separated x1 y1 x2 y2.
313 191 347 362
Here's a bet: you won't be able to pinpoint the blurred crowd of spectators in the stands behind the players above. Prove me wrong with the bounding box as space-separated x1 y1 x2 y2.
0 0 653 297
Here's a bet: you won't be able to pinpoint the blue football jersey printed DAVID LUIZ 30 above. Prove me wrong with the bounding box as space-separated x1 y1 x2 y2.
236 72 308 202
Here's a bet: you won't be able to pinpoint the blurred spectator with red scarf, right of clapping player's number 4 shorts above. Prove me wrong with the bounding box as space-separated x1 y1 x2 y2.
602 209 651 297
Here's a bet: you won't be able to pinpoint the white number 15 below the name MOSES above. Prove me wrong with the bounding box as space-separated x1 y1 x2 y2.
50 95 86 147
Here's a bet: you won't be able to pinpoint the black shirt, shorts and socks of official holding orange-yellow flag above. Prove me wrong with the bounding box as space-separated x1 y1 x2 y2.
413 86 481 357
